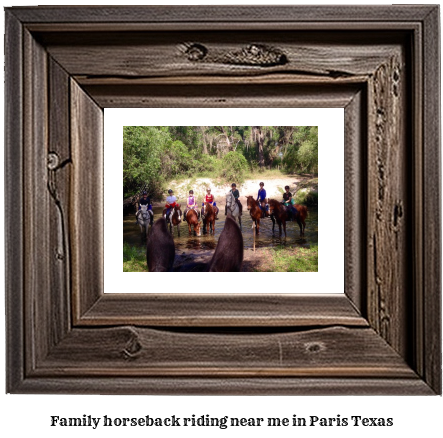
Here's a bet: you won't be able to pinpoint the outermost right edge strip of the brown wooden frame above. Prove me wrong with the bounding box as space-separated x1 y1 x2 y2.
420 8 442 393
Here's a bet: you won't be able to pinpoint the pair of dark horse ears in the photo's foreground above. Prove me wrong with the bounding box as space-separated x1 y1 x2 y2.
146 216 243 272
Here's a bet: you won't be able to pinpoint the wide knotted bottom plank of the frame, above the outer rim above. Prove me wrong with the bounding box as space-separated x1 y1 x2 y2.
37 326 417 379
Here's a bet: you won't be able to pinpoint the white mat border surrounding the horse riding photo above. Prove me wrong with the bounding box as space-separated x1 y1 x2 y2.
104 108 344 293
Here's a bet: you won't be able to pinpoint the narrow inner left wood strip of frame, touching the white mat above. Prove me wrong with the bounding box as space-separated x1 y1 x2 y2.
69 79 104 320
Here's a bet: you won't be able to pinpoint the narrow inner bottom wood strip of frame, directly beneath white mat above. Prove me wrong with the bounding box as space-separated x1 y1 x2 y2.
78 294 368 327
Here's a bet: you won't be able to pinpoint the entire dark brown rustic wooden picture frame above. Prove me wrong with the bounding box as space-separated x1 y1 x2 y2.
5 6 441 394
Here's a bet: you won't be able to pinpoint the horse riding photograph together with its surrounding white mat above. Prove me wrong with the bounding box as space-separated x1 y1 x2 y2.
110 108 344 294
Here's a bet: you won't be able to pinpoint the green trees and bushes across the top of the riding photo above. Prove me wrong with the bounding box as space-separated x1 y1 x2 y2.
123 126 318 203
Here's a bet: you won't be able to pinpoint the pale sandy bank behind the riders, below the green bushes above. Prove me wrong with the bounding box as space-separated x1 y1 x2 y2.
159 175 306 205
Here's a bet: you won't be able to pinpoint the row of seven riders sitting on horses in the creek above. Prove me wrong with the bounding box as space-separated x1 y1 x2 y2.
136 182 297 225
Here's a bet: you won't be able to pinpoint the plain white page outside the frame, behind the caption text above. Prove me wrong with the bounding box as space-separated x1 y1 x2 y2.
0 0 443 438
